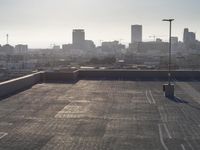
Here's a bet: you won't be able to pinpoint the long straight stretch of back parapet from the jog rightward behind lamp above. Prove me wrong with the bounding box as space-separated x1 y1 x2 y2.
78 70 200 80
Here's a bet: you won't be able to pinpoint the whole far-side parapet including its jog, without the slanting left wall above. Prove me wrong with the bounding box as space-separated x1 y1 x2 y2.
41 70 200 82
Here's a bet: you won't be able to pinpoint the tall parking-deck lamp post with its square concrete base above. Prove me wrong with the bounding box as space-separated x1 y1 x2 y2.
162 19 174 98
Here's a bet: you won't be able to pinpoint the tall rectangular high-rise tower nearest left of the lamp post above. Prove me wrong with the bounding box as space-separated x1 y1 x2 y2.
131 25 142 43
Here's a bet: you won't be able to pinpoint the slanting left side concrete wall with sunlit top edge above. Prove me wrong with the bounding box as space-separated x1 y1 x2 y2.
0 72 42 98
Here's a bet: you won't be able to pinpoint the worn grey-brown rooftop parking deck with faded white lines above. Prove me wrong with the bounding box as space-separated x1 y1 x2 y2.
0 80 200 150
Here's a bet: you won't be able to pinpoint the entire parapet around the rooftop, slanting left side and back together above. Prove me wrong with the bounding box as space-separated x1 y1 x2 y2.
0 70 200 99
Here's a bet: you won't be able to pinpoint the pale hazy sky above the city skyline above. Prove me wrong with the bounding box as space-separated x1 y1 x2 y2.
0 0 200 48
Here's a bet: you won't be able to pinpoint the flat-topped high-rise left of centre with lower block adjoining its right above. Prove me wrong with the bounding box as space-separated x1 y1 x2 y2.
72 29 85 49
